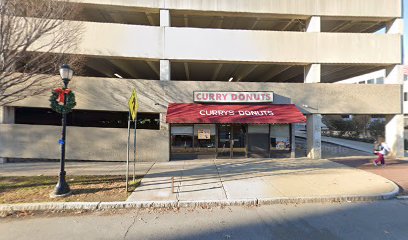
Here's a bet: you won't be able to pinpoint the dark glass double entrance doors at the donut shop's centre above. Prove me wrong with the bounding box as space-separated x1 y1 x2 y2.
217 124 246 158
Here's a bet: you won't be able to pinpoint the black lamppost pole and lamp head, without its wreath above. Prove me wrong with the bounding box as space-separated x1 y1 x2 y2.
53 64 74 197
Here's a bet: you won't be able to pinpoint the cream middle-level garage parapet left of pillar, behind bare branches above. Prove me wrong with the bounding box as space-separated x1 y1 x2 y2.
29 21 164 59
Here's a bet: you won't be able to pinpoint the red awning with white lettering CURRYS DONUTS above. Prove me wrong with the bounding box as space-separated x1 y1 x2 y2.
167 103 306 124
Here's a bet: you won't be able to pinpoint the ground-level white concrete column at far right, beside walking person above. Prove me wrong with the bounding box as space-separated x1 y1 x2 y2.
385 114 404 158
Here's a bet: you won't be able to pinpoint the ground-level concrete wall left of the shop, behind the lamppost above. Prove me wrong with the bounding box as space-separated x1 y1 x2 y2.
0 124 169 162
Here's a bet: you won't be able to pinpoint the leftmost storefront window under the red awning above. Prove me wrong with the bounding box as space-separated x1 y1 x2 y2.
171 126 193 152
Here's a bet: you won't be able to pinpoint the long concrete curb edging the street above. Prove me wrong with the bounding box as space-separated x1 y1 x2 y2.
0 186 400 212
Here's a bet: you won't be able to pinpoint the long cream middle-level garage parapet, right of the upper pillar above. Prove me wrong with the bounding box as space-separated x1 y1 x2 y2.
164 28 402 64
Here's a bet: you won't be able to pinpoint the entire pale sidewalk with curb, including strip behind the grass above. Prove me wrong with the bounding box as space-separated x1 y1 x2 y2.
0 158 399 211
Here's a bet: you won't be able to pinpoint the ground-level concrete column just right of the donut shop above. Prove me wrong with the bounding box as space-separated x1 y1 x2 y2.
306 114 322 159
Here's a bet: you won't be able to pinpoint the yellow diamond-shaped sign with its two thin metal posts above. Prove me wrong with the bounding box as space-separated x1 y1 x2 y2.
126 89 139 192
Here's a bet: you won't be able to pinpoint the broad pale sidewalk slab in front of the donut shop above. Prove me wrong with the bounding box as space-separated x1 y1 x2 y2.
128 158 398 202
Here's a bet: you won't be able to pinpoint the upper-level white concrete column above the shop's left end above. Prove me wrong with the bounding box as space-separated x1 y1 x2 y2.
160 9 171 81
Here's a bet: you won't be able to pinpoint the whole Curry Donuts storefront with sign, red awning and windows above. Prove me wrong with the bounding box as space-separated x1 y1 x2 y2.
166 91 306 160
